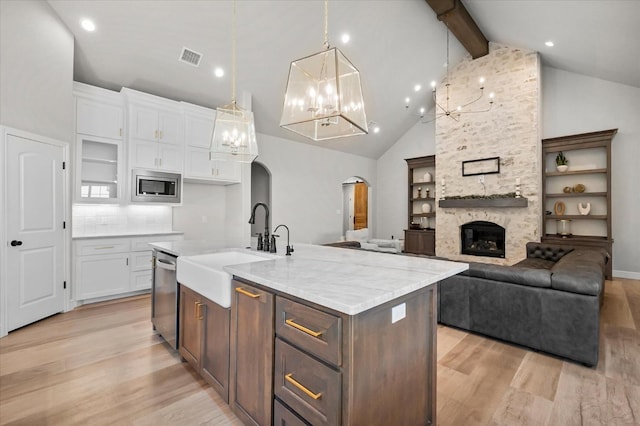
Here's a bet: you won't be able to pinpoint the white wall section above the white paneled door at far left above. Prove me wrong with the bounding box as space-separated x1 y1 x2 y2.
0 0 74 142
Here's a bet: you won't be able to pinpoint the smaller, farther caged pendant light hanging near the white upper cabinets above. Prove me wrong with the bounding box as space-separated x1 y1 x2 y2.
209 0 258 163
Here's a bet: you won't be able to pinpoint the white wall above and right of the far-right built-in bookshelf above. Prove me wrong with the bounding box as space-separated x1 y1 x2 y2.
542 67 640 279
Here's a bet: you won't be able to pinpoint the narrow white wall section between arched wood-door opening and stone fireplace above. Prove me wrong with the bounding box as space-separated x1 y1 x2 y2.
374 118 436 238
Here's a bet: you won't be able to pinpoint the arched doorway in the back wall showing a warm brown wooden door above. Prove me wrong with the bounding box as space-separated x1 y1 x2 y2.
342 176 370 235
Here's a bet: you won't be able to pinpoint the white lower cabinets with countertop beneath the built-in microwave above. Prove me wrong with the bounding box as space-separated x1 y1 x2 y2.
73 234 183 303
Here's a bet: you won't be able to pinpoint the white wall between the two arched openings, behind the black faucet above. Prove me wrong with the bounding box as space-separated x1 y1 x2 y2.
254 134 377 246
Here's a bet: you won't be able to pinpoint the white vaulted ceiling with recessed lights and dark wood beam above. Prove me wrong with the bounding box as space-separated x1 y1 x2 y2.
48 0 640 158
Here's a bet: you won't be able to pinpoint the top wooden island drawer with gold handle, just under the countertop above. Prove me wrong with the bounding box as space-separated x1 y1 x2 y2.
276 296 342 366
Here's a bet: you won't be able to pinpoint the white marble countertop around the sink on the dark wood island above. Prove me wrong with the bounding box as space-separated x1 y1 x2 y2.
224 244 469 315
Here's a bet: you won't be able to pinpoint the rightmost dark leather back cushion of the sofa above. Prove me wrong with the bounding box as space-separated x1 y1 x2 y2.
551 250 607 296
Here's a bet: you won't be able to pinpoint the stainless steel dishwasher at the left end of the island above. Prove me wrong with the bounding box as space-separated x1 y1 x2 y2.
151 250 178 349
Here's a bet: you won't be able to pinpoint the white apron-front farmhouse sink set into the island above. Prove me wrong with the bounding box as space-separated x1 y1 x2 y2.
176 251 275 308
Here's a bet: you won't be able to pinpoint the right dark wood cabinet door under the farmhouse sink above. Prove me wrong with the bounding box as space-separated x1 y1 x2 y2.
200 298 229 402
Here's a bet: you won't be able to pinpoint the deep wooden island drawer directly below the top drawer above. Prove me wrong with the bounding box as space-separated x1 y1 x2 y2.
273 339 342 425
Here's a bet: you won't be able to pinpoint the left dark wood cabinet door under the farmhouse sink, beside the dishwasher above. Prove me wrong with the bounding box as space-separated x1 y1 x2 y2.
179 285 202 371
